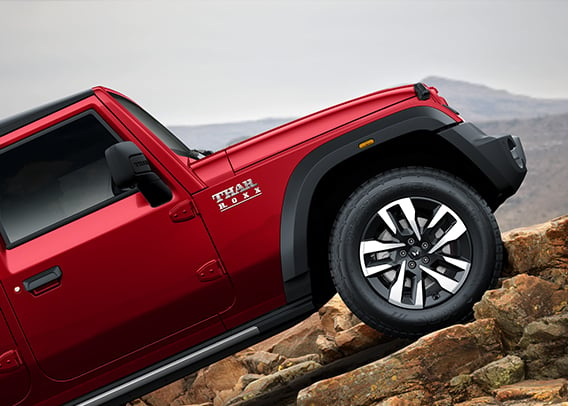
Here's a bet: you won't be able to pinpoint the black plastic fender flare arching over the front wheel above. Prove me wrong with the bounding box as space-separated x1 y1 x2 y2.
280 106 458 302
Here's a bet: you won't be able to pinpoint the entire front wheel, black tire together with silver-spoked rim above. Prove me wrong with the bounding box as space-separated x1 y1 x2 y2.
329 167 503 337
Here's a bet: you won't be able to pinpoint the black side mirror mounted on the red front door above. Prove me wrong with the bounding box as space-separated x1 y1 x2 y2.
105 141 172 207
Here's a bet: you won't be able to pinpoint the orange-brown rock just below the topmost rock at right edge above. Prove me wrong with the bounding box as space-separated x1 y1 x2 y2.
474 274 568 346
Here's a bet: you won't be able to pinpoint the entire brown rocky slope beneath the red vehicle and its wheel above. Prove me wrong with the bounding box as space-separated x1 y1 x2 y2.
132 215 568 406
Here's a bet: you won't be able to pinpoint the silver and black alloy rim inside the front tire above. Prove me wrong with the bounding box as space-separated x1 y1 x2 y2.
359 197 472 309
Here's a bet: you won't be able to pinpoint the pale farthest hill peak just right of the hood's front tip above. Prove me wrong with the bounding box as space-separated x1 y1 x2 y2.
423 76 568 122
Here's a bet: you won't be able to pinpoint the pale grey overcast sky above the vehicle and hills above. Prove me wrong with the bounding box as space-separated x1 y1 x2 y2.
0 0 568 125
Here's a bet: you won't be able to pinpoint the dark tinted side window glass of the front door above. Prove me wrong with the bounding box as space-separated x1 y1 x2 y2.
0 110 119 248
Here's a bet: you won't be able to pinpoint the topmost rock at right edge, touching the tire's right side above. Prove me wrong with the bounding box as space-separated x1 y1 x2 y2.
502 215 568 286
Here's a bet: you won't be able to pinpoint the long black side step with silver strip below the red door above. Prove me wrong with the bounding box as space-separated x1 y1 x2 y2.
69 297 315 406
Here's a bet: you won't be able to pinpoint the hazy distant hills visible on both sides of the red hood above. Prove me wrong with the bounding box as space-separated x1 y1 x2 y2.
166 77 568 230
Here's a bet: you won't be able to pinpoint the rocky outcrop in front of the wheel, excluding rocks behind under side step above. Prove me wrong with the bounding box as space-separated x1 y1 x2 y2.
297 216 568 406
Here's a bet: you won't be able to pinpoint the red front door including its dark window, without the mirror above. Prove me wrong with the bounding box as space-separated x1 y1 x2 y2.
0 108 234 380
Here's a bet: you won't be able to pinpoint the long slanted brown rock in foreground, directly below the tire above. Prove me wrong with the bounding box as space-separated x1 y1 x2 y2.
297 319 503 406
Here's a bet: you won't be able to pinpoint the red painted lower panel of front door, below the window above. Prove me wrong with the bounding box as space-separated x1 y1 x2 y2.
2 193 233 380
